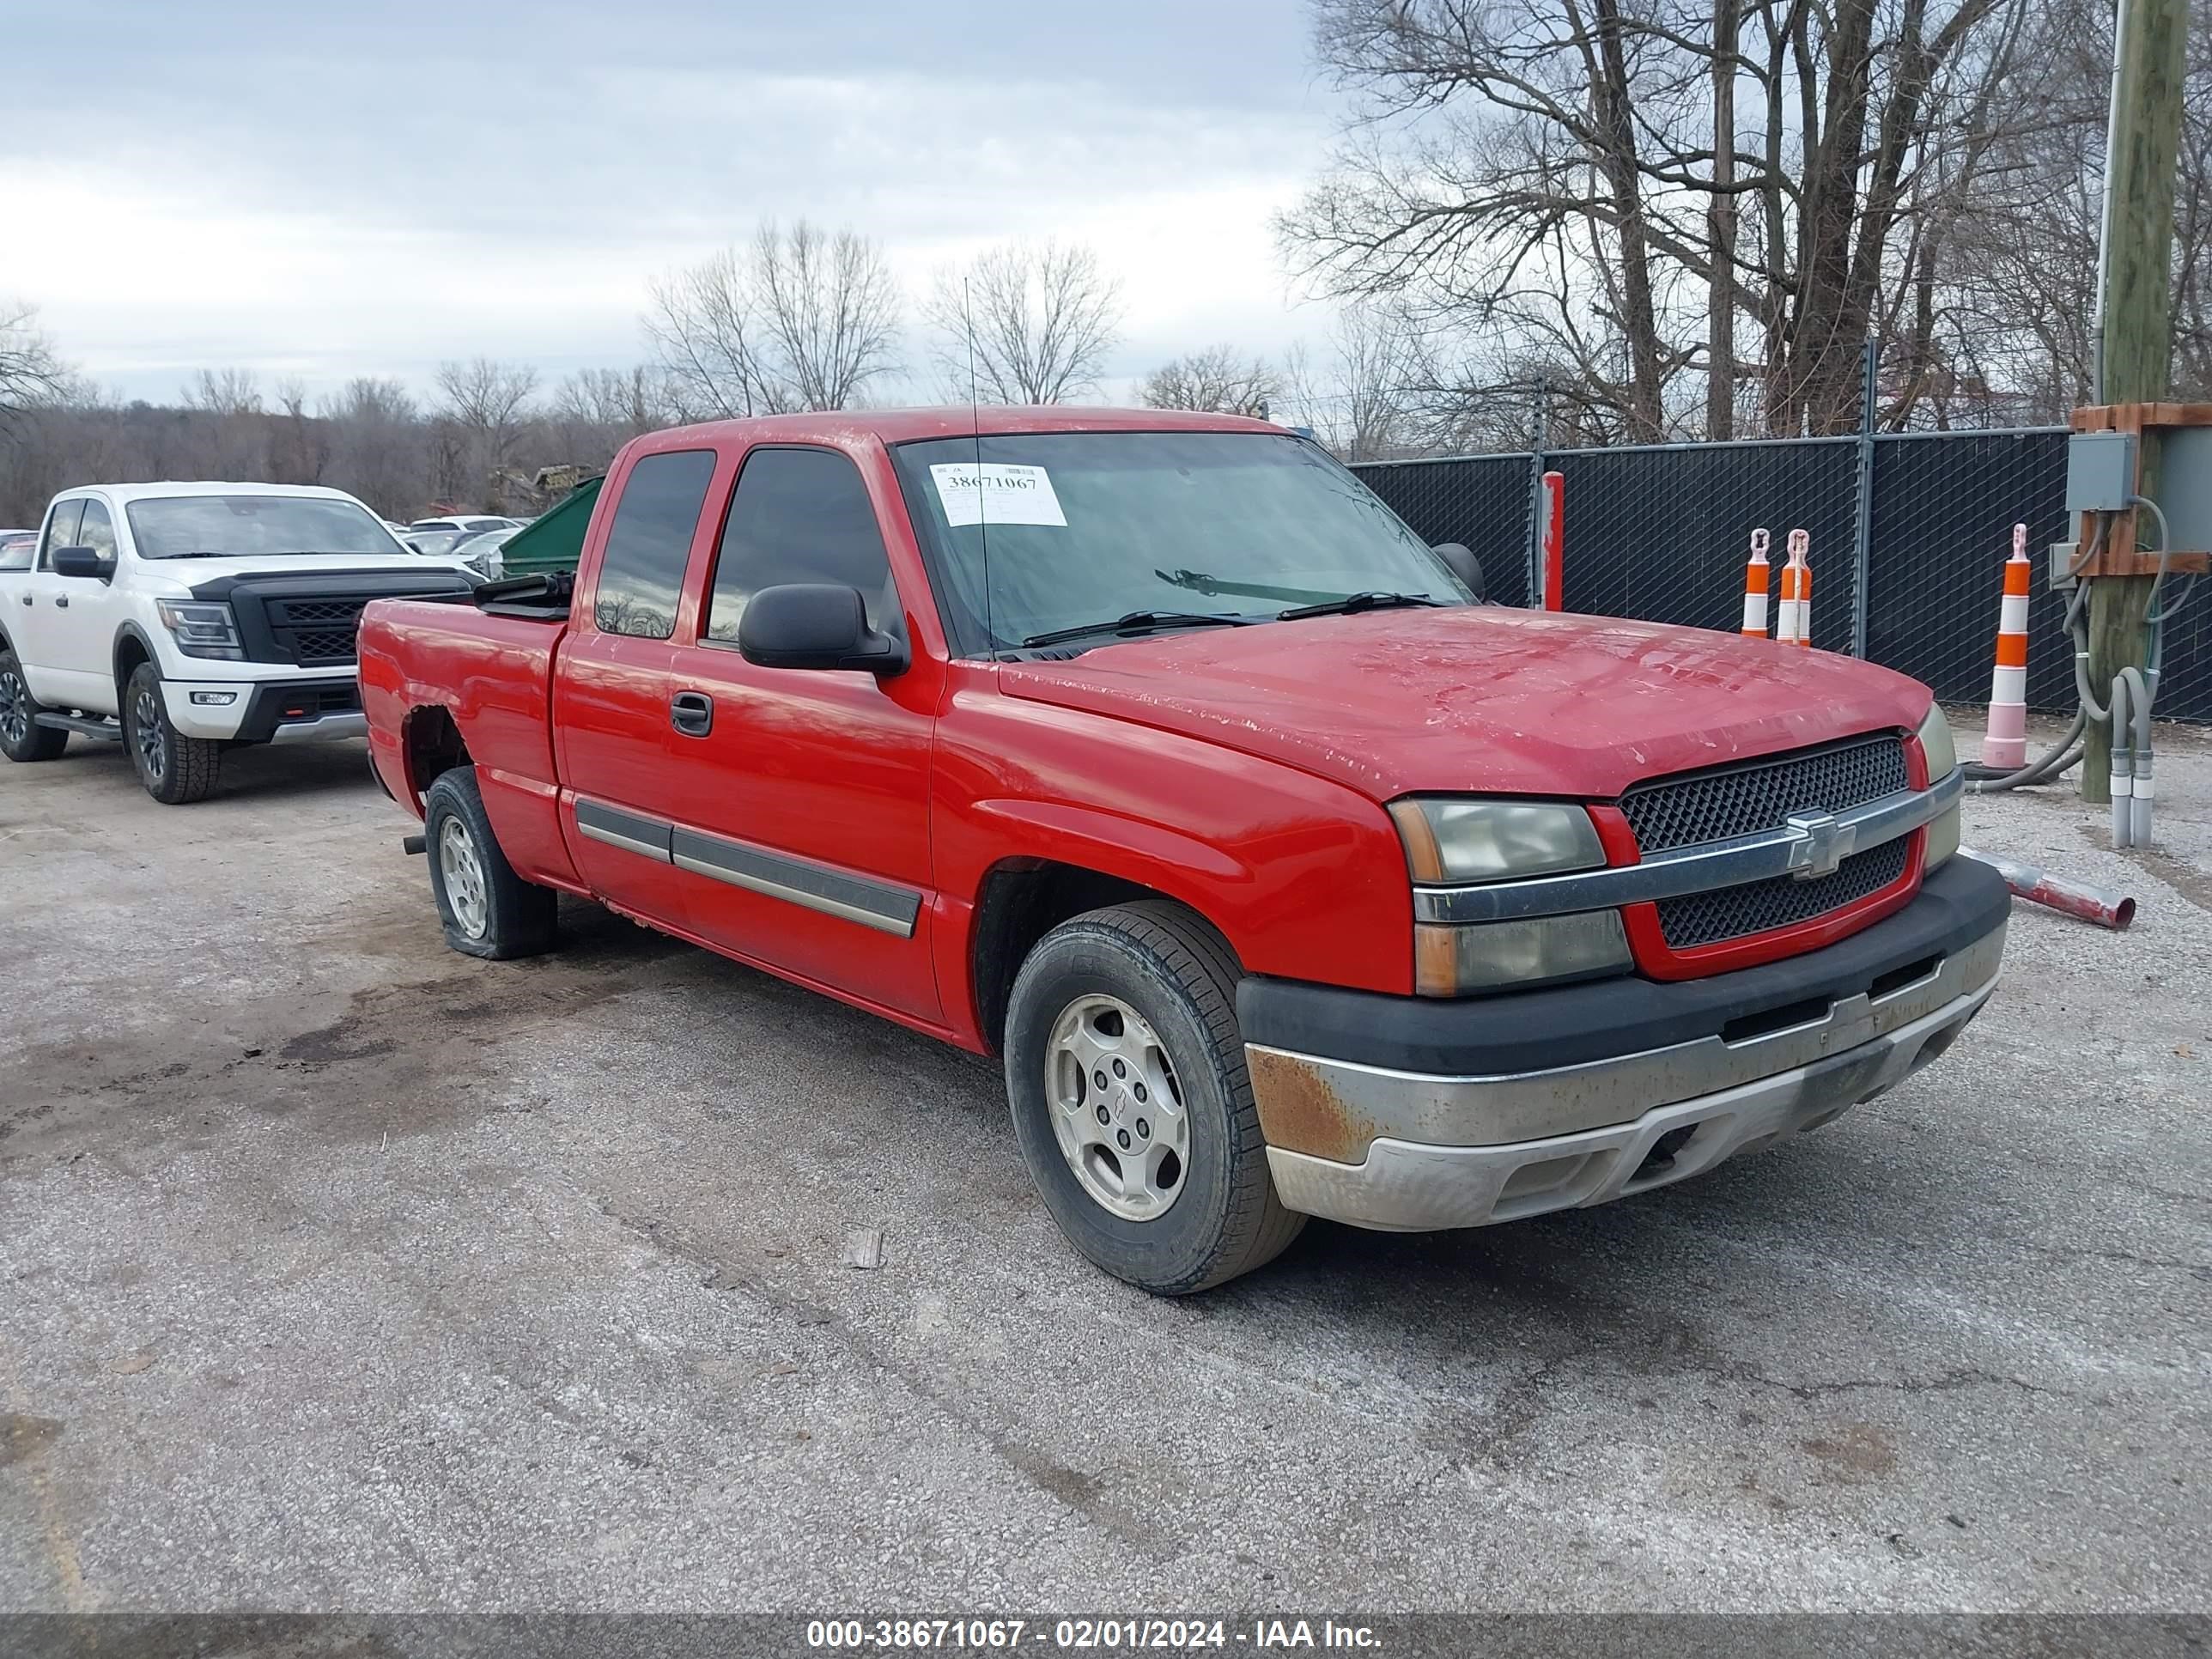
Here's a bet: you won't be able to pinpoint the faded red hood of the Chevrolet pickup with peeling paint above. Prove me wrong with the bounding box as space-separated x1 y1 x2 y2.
1000 606 1929 801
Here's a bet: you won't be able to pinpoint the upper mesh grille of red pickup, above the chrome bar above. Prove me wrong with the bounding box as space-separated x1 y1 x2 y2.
1621 732 1911 849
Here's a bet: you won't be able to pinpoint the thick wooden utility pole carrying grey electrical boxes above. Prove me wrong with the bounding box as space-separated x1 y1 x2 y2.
2081 0 2190 803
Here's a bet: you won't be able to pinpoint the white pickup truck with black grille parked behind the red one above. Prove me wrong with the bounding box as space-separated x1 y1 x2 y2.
0 484 471 805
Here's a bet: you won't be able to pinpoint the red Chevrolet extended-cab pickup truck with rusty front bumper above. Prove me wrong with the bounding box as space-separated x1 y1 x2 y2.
361 410 2008 1294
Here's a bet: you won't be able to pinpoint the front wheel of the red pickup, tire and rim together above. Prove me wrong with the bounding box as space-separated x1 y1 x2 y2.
1006 900 1305 1297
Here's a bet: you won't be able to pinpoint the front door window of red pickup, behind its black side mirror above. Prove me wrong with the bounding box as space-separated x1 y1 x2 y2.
706 449 898 644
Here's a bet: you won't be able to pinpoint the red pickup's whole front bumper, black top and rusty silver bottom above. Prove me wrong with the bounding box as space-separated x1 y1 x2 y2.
1239 858 2011 1232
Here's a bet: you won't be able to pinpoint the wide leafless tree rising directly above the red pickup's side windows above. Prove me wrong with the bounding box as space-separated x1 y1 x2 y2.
644 219 900 418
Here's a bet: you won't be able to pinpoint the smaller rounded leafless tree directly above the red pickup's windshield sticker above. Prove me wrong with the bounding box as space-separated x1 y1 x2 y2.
922 239 1121 403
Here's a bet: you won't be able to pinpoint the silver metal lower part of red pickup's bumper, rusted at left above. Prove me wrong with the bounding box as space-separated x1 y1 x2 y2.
1245 927 2004 1232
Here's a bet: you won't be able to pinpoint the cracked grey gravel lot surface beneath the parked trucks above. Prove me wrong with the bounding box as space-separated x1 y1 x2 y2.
0 728 2212 1613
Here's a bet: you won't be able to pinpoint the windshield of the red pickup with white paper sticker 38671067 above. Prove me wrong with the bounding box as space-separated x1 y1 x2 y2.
891 431 1474 657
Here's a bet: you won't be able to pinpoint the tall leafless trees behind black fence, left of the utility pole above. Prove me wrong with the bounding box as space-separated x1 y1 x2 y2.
1279 0 2052 438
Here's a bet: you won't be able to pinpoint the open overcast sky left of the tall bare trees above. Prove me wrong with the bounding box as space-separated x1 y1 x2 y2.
0 0 1336 398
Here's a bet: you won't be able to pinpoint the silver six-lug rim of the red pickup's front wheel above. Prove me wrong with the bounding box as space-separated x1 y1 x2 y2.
1044 995 1190 1221
